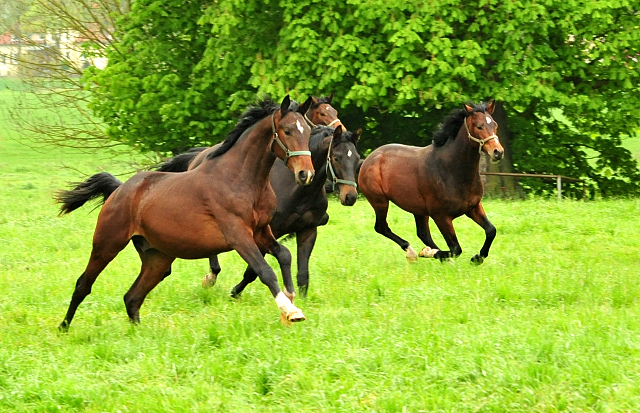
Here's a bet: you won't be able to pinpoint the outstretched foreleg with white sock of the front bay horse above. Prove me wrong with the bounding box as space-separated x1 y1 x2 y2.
234 229 305 321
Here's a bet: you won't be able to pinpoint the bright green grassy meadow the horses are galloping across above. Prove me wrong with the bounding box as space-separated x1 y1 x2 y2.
0 84 640 412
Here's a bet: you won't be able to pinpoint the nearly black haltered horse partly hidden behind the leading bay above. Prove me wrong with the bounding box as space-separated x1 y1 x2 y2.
155 126 362 298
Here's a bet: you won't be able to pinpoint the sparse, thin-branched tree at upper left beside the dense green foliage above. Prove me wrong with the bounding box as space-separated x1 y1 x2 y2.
2 0 129 149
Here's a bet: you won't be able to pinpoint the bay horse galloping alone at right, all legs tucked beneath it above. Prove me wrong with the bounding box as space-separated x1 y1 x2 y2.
358 100 504 264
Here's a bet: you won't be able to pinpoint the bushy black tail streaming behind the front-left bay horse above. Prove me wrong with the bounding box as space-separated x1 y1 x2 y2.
55 172 122 215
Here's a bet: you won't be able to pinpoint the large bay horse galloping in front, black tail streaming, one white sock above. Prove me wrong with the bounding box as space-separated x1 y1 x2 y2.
56 96 315 331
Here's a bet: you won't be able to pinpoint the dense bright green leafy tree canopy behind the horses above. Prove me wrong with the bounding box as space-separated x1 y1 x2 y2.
85 0 640 196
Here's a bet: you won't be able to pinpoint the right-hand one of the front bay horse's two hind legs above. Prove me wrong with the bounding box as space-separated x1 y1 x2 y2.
124 249 175 324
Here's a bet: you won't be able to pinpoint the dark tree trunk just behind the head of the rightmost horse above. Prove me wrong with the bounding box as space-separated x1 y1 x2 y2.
480 102 524 199
